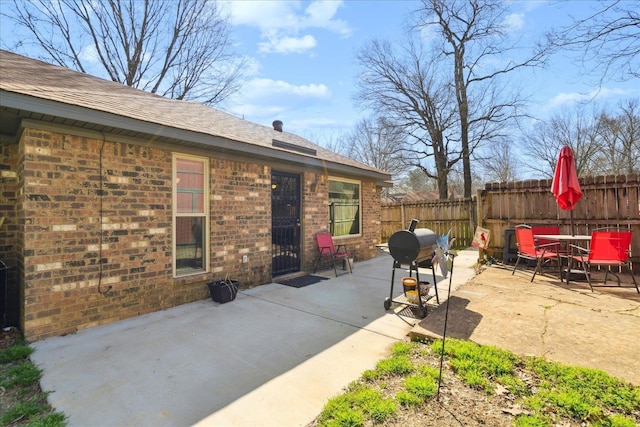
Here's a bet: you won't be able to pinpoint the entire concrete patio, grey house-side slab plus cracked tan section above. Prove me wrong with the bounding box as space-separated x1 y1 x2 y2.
32 249 640 426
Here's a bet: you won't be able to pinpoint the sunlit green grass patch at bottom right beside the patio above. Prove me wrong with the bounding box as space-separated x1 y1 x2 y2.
315 339 640 427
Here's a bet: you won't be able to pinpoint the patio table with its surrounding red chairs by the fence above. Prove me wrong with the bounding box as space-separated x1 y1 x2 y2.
511 224 640 293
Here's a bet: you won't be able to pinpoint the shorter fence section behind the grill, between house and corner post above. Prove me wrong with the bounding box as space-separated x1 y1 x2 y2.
381 199 476 246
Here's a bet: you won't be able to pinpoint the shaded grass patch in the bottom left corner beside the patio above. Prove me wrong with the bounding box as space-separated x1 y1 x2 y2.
0 339 66 427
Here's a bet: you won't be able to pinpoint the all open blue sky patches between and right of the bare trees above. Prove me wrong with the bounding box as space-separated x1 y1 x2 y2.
218 0 640 143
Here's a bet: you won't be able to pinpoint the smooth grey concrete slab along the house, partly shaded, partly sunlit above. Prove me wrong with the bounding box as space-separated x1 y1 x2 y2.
32 249 477 426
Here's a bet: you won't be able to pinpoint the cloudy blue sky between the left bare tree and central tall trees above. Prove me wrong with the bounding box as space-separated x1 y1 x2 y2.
220 1 415 136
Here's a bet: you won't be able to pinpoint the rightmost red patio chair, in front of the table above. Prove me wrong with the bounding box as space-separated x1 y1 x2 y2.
567 228 640 294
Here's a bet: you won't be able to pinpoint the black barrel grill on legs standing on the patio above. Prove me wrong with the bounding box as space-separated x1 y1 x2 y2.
384 219 440 317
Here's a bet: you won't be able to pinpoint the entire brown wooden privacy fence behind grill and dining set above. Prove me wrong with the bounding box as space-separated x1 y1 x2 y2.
381 174 640 272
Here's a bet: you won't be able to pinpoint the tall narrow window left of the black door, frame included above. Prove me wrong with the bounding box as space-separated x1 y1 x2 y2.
173 156 209 276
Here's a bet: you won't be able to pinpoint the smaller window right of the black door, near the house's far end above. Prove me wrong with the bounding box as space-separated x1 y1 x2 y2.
329 178 360 237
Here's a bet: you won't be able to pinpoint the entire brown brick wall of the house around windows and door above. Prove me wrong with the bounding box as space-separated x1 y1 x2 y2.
0 129 380 340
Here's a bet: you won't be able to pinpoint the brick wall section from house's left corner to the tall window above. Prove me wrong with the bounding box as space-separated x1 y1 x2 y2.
20 129 175 339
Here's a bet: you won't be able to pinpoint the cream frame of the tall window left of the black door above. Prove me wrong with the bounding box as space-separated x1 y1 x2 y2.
171 153 211 278
